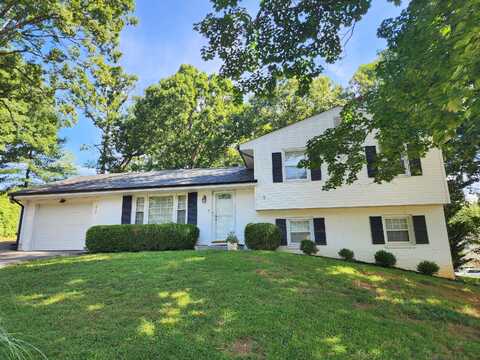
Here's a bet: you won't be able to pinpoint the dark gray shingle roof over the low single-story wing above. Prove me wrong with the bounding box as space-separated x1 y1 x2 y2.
11 167 256 196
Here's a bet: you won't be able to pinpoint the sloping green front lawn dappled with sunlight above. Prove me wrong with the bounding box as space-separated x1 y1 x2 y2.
0 251 480 359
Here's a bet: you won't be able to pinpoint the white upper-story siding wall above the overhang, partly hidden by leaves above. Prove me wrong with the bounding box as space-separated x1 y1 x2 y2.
241 108 449 210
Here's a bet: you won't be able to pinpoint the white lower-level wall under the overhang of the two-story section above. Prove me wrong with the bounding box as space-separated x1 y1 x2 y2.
257 205 454 277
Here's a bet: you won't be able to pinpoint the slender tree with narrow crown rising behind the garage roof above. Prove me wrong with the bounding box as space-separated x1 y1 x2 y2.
74 58 137 174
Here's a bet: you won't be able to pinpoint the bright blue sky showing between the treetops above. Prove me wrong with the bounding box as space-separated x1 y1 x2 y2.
60 0 401 175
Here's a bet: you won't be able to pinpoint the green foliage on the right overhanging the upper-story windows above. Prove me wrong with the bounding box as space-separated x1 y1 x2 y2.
307 0 480 189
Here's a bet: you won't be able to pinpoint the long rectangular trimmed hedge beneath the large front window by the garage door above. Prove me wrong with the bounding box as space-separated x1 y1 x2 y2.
86 224 199 252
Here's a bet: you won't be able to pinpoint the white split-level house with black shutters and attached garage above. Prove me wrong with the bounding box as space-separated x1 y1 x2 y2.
11 108 454 277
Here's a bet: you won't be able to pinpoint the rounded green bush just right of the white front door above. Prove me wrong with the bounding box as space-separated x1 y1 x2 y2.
245 223 282 250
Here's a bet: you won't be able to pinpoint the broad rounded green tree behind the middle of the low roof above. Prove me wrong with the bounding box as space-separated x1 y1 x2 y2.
123 65 242 170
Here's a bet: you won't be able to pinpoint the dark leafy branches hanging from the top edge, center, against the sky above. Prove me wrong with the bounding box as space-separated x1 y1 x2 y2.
195 0 370 93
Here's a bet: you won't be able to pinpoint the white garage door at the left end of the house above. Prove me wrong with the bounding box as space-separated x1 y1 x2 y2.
33 200 92 250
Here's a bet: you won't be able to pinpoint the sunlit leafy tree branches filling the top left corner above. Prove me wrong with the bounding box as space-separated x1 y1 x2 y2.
0 0 135 121
